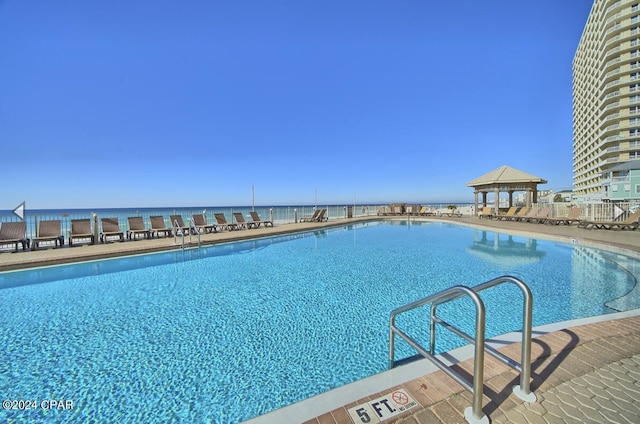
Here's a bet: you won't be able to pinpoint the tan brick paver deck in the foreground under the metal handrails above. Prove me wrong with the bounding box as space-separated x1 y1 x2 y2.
305 316 640 424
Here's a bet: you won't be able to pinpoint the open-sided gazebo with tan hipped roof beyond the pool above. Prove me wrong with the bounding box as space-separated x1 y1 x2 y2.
467 165 547 213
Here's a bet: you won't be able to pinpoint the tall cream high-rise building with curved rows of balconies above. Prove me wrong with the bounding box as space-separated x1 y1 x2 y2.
573 0 640 201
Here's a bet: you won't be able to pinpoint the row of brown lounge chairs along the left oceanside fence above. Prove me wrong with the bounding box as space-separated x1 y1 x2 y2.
0 212 273 252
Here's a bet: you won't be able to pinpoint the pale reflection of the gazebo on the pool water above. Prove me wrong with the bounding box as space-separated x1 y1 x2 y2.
467 229 547 268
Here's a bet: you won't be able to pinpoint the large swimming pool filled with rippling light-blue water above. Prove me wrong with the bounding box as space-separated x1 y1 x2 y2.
0 222 640 423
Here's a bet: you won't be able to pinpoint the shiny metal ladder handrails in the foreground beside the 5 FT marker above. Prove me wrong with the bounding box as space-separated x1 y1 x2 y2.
389 275 536 423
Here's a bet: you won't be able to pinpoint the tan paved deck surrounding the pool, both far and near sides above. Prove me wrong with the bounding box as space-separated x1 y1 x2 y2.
0 217 640 424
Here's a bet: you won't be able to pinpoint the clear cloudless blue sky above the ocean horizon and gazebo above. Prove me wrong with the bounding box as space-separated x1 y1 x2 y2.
0 0 592 209
